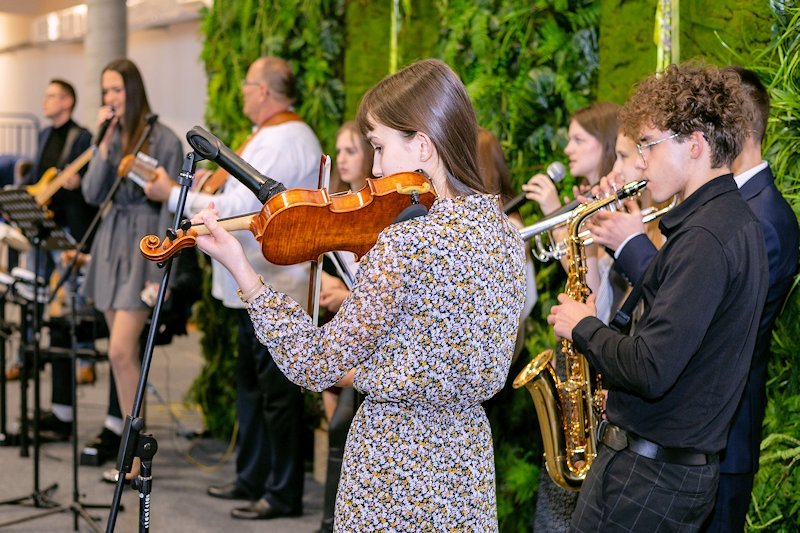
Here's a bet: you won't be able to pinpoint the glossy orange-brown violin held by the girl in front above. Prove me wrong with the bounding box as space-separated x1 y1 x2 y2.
139 172 436 265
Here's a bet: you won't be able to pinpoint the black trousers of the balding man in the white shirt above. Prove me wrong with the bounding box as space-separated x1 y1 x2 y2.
236 309 305 513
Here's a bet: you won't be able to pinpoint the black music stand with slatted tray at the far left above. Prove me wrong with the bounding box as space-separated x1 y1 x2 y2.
0 189 74 527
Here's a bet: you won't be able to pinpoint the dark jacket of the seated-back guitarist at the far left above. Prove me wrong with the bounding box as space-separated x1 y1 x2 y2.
30 122 97 240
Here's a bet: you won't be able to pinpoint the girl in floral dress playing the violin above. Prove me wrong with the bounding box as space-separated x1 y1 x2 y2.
197 60 525 531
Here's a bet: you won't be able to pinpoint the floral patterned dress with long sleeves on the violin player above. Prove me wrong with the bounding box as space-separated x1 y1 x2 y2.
248 194 525 532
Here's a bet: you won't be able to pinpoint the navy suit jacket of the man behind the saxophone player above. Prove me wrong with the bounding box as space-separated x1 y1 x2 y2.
614 167 800 474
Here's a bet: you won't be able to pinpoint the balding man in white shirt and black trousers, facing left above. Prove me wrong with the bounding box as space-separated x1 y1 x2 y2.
145 57 322 519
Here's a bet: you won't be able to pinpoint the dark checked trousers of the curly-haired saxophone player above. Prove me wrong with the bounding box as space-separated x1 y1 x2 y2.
570 444 719 533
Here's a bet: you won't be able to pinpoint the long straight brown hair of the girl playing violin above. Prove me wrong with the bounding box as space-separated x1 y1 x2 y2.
357 59 487 194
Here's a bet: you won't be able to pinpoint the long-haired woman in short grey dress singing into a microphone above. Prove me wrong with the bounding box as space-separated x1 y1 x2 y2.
82 59 182 481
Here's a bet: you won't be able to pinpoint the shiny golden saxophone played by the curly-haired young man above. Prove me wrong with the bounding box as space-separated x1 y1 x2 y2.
513 180 647 491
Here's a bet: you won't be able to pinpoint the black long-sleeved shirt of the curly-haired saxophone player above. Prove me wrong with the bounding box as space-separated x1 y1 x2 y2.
572 174 768 453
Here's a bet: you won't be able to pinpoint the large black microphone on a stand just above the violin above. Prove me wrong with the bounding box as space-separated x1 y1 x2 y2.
186 126 286 204
